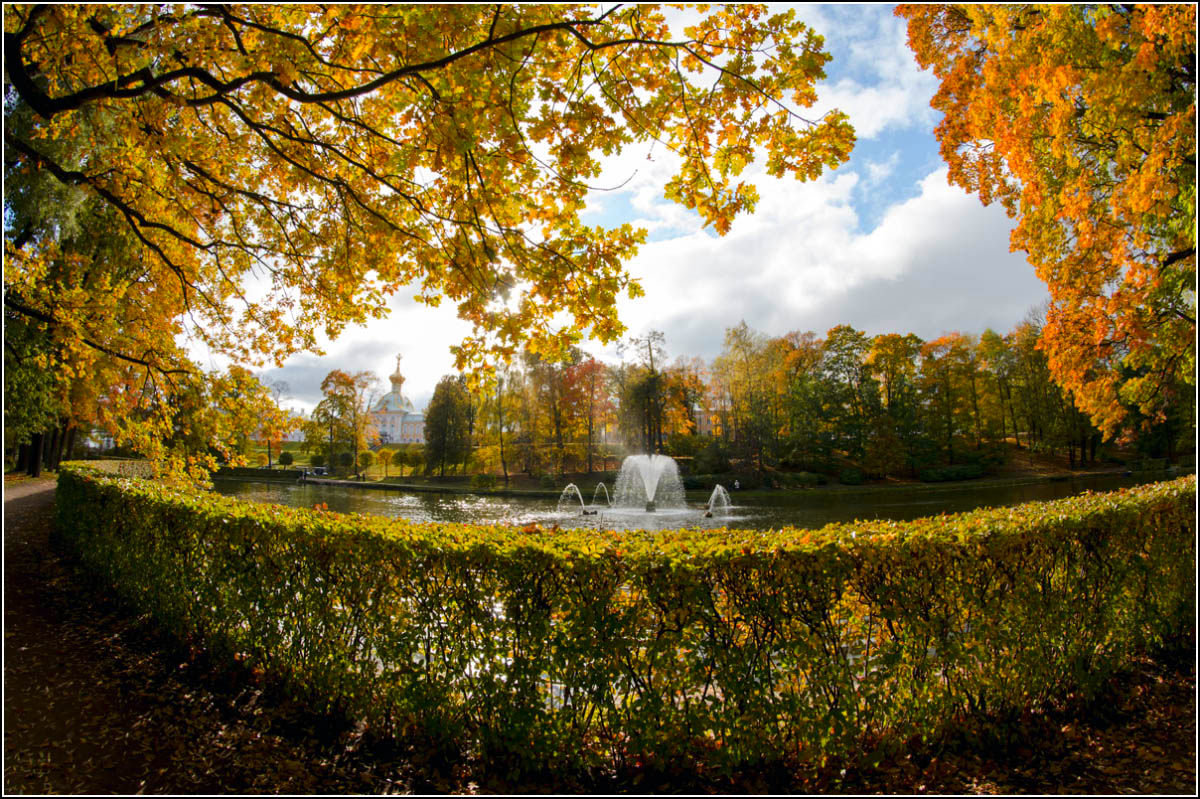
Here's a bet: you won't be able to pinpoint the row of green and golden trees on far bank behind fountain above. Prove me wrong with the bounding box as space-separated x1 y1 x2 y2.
391 314 1194 477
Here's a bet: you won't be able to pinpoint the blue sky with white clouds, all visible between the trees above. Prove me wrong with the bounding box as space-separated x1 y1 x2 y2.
246 4 1049 411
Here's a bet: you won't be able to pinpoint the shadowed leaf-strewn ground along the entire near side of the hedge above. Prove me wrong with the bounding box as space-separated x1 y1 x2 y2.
4 472 1196 794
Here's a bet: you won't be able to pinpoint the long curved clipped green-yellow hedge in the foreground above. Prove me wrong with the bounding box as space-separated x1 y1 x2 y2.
58 465 1195 768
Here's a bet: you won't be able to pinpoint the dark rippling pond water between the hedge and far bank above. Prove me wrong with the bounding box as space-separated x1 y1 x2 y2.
214 475 1161 530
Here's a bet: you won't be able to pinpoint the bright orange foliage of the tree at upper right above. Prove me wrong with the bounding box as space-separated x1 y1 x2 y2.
896 5 1196 435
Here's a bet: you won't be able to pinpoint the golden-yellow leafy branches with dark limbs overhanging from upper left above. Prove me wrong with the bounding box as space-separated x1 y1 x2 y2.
4 4 853 472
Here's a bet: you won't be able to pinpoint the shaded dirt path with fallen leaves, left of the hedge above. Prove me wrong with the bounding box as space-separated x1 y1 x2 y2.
4 480 422 794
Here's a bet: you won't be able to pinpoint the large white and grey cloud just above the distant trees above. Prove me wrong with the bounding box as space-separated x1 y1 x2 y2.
595 168 1045 358
